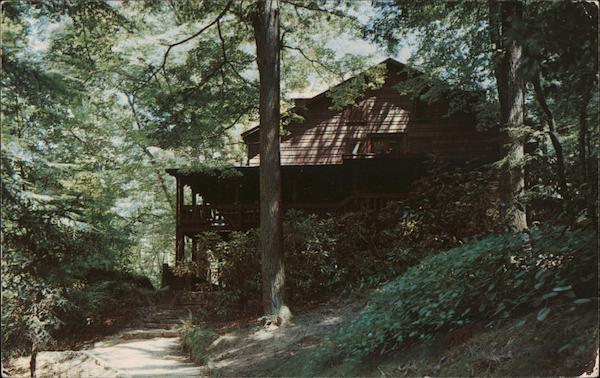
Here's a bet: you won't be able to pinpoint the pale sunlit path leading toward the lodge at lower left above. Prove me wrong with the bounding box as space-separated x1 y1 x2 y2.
7 306 204 378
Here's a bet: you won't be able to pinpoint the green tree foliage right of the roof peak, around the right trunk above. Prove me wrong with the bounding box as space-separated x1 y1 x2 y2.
364 1 598 223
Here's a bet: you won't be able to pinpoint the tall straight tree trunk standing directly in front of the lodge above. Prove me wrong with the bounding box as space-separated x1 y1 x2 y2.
253 0 289 322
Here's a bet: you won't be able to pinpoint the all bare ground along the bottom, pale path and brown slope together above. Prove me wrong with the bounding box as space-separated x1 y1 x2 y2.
5 297 598 377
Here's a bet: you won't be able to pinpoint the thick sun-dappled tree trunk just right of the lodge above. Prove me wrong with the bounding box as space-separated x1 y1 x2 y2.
490 1 527 232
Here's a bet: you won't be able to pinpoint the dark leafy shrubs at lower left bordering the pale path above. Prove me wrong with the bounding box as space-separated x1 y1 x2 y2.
2 270 151 359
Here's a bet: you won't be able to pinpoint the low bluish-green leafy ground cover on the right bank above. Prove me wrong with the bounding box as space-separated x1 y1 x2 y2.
310 228 598 363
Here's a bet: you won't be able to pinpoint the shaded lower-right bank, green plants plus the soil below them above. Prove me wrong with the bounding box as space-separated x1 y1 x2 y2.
261 228 598 376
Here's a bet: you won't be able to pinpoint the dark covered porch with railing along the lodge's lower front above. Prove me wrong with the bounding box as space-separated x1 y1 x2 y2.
162 157 425 289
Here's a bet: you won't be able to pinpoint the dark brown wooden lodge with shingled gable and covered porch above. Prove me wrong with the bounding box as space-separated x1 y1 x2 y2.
163 59 500 285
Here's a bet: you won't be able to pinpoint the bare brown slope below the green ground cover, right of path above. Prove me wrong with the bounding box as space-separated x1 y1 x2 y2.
186 298 598 377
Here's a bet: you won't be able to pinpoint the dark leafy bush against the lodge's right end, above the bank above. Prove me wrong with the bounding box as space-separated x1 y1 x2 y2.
379 163 499 251
